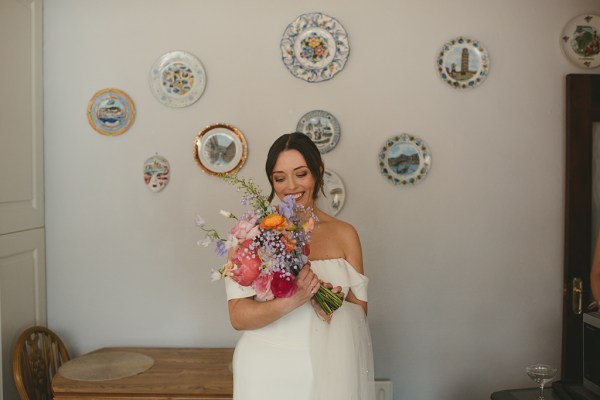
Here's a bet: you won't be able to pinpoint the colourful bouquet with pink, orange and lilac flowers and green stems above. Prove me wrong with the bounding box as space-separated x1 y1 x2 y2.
196 175 343 315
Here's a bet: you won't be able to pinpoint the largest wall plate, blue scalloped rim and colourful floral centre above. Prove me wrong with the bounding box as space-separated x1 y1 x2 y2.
280 13 350 82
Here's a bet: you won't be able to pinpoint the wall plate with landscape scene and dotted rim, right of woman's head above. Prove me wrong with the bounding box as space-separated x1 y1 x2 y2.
379 133 431 185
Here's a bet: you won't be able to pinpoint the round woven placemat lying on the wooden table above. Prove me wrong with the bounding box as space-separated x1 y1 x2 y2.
58 351 154 381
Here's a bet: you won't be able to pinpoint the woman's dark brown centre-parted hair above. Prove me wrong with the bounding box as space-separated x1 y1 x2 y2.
265 132 325 201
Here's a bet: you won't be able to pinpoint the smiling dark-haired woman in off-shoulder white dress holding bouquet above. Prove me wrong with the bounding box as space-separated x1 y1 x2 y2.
226 133 375 400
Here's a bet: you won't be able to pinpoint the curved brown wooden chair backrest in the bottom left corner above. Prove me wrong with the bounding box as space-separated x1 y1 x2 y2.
12 326 69 400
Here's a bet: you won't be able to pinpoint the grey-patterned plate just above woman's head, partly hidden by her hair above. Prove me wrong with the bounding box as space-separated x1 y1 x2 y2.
296 110 341 154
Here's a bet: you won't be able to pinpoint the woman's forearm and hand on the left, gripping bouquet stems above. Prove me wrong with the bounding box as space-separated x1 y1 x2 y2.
228 264 320 330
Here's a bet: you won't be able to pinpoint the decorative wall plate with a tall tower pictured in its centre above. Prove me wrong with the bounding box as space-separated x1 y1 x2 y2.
437 36 490 89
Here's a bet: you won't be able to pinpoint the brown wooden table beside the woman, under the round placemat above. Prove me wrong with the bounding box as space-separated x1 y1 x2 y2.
52 347 233 400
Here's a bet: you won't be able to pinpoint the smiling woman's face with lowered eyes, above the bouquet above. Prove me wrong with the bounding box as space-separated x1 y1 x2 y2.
272 150 315 208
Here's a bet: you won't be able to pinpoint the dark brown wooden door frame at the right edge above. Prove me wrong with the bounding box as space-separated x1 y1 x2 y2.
561 74 600 384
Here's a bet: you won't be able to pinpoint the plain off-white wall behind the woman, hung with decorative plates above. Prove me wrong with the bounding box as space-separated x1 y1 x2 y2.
44 0 598 400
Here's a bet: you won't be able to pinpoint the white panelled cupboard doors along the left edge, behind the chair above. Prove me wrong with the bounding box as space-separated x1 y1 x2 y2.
0 0 46 400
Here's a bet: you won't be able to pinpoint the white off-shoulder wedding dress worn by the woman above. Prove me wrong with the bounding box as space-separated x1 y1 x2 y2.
226 259 375 400
